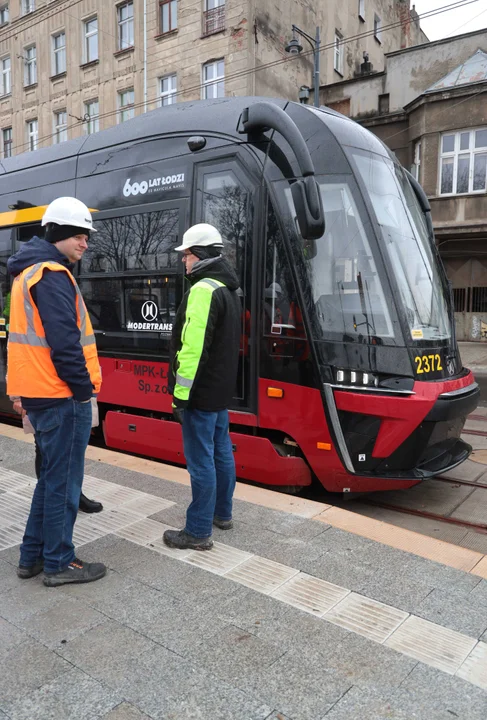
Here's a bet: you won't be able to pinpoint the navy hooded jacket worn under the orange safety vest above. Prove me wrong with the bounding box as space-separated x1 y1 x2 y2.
7 237 93 411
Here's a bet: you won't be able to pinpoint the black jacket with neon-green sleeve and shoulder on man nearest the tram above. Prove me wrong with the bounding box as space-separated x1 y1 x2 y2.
169 257 242 412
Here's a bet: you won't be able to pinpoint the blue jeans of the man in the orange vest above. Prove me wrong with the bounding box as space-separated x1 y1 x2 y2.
20 398 91 573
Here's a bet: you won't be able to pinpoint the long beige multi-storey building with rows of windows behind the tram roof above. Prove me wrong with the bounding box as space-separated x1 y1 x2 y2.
0 0 425 157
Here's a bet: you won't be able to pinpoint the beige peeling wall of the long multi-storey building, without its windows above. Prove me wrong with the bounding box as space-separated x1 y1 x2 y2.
0 0 424 152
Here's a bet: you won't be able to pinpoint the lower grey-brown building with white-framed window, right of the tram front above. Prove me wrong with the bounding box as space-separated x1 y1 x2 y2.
320 30 487 341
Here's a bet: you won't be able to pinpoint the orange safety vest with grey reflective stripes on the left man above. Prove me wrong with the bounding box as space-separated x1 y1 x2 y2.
7 262 101 398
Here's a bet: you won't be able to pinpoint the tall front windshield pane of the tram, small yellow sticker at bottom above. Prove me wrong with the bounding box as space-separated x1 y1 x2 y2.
353 150 450 341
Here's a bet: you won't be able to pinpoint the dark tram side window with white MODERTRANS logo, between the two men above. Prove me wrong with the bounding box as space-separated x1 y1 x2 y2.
79 209 182 356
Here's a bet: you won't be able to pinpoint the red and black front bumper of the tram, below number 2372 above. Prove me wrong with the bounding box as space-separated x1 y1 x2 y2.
335 373 480 480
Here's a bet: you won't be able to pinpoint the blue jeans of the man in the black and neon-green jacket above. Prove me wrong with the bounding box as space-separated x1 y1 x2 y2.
183 410 236 538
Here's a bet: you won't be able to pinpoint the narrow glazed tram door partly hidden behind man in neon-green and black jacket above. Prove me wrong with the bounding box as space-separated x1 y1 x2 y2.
195 157 255 410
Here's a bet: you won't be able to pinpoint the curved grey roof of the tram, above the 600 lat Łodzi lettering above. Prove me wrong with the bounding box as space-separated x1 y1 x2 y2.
0 97 387 179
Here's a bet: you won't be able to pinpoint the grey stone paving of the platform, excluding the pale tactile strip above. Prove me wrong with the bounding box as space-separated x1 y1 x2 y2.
0 438 487 720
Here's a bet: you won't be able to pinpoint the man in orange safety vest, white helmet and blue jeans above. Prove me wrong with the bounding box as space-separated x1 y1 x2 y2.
7 197 106 587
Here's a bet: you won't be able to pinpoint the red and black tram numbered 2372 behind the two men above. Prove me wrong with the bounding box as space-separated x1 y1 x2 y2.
0 98 479 492
